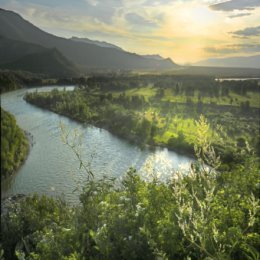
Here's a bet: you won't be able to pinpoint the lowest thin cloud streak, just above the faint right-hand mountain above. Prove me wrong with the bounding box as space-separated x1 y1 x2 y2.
204 44 260 54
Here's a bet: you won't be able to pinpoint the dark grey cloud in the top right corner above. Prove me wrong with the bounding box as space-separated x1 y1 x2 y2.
210 0 260 12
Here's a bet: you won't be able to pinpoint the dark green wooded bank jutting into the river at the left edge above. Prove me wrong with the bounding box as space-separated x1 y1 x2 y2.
1 108 29 178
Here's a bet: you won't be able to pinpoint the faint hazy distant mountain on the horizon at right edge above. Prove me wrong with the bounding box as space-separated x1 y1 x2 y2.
194 55 260 68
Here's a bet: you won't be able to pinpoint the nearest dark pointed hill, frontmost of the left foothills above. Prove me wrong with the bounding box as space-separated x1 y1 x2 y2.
0 49 78 77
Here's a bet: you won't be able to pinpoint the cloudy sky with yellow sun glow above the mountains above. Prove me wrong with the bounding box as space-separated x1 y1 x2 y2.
0 0 260 64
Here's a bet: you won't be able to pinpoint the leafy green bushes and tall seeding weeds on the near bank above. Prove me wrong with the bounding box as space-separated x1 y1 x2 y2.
1 118 260 260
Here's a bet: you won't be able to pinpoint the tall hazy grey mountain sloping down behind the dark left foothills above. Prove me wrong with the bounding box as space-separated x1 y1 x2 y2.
0 9 177 71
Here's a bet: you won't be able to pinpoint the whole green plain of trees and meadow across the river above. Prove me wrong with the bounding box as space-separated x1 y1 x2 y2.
25 75 260 164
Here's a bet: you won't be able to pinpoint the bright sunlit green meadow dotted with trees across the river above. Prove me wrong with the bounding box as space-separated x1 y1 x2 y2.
96 78 260 160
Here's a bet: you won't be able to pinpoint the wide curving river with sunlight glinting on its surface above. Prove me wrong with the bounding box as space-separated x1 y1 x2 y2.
1 87 193 203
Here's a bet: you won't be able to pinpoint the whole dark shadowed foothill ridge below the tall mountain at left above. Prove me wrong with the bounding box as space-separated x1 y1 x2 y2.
0 37 78 76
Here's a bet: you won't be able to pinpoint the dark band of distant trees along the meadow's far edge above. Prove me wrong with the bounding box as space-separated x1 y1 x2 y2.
86 75 260 97
